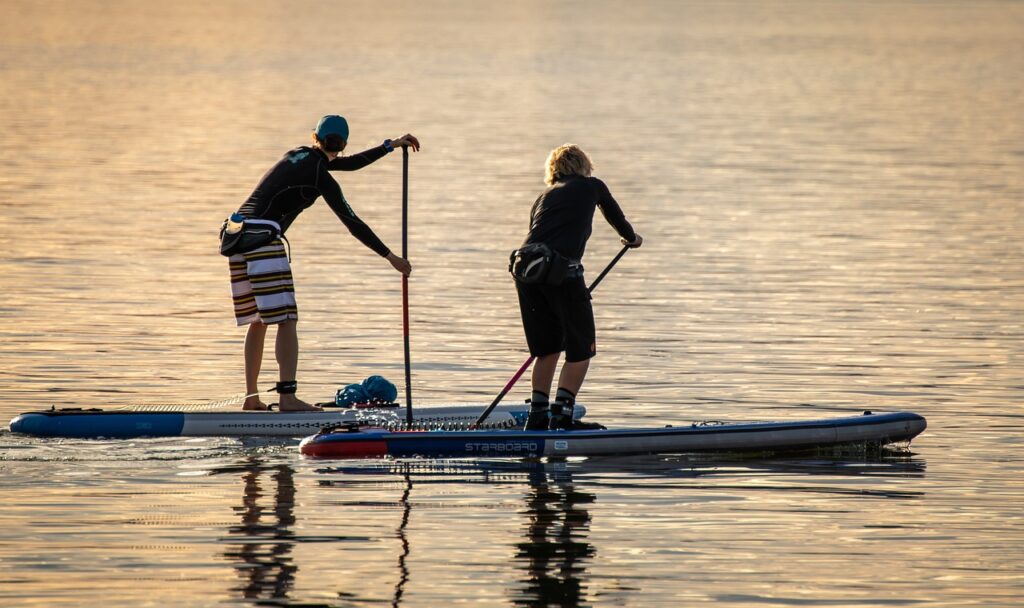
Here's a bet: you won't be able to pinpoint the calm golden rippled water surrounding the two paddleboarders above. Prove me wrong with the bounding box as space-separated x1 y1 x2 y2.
0 0 1024 606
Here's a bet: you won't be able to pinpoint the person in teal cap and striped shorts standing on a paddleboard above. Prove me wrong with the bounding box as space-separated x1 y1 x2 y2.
228 115 420 411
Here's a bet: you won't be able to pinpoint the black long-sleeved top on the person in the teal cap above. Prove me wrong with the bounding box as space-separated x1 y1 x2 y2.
239 145 390 257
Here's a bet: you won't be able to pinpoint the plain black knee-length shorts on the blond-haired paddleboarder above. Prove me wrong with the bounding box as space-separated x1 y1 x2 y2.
516 276 597 362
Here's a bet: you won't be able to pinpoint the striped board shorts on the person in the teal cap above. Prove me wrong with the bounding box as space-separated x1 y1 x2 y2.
227 238 299 325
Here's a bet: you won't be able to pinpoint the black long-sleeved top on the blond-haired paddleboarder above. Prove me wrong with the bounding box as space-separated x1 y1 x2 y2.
523 176 637 261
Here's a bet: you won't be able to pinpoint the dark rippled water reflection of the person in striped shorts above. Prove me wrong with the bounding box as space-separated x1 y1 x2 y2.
224 461 299 600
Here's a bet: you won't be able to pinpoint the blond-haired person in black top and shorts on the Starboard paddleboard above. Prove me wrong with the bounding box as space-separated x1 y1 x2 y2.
513 143 643 431
